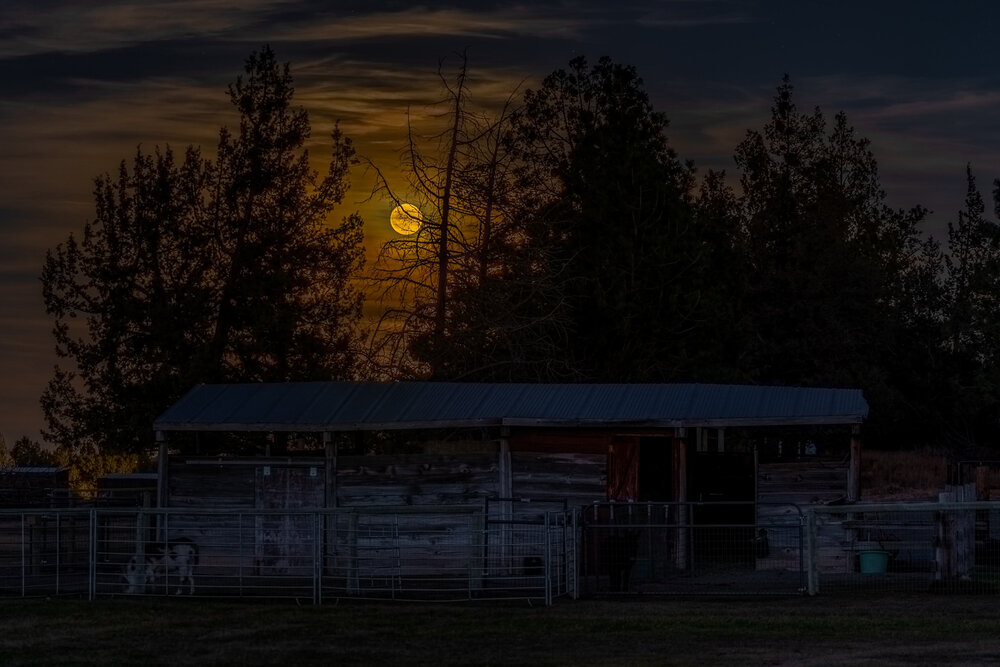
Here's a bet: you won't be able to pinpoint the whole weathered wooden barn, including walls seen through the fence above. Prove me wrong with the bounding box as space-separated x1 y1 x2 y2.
145 382 868 589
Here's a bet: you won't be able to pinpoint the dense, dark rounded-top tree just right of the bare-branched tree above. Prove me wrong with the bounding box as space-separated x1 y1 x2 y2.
513 58 704 381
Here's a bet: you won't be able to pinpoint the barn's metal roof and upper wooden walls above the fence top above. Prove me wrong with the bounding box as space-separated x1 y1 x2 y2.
154 382 868 507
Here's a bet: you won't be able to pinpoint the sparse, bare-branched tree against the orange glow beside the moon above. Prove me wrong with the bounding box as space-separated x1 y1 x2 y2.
374 54 556 379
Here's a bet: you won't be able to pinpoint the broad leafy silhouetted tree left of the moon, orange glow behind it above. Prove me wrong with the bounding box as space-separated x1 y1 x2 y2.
42 48 362 452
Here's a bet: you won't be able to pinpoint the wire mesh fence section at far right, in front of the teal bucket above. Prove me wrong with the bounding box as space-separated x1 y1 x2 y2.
809 502 1000 594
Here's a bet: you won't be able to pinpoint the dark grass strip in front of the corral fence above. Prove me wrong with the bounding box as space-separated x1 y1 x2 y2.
0 595 1000 667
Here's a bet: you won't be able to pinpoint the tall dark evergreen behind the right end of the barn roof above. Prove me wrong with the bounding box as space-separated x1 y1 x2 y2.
736 77 933 446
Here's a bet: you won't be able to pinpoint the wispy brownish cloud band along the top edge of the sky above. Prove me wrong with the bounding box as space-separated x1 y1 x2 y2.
0 0 752 58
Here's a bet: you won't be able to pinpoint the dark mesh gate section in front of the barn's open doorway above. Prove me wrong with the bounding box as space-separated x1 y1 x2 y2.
581 502 806 595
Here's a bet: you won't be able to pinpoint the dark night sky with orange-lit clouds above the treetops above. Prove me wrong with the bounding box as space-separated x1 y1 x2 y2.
0 0 1000 443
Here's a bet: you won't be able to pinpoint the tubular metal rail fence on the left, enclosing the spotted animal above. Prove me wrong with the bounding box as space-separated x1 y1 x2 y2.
0 505 578 604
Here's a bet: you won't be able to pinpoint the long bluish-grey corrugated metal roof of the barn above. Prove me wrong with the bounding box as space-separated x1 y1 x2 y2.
153 382 868 431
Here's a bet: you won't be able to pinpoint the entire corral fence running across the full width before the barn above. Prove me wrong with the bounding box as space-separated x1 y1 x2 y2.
0 494 1000 604
